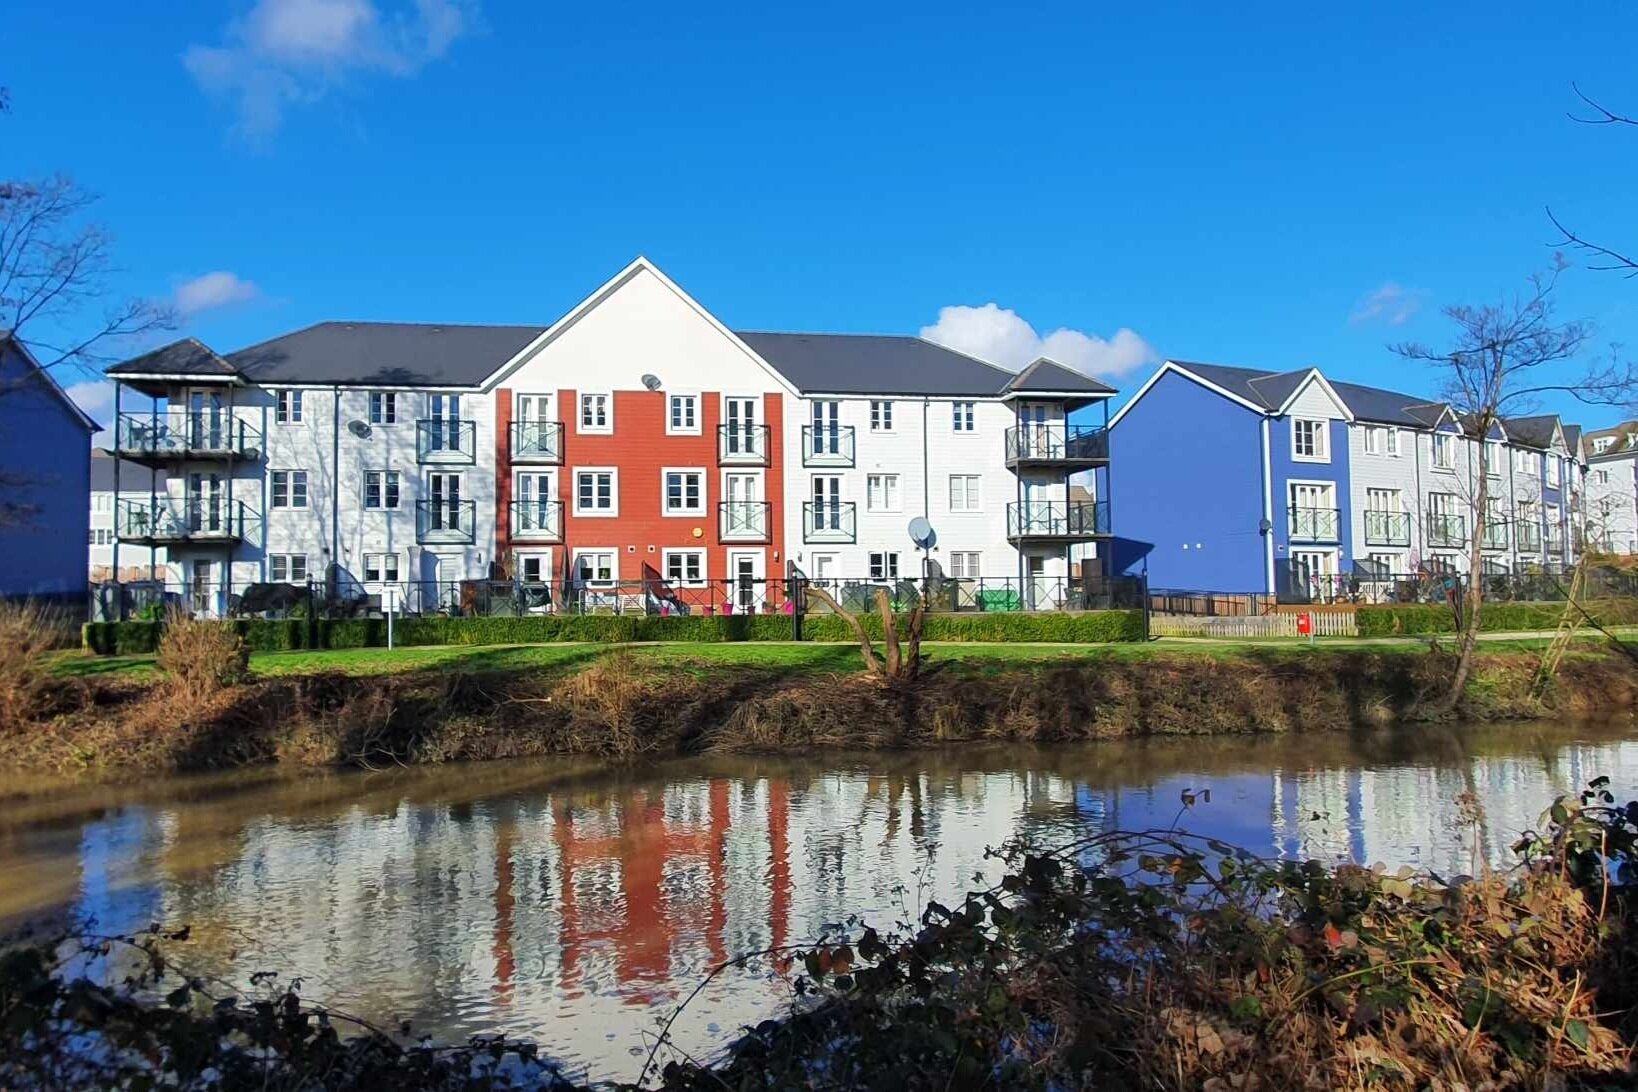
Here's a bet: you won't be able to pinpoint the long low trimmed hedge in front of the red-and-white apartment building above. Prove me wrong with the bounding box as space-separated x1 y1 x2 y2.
84 611 1143 657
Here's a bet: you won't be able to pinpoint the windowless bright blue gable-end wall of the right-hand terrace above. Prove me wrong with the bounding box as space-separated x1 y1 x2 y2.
1109 372 1268 591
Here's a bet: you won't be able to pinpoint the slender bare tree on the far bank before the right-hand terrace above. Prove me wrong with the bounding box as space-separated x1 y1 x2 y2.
1391 257 1638 712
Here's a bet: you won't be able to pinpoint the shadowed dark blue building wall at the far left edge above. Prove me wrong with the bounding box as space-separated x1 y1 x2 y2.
0 347 92 602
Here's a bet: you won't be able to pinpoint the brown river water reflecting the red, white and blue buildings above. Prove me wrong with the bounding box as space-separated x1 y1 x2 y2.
0 722 1638 1079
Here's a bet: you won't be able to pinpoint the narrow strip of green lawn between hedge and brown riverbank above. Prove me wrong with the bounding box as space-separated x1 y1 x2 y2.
56 637 1624 678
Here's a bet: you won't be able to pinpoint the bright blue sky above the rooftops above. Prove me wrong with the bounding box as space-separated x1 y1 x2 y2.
0 0 1638 426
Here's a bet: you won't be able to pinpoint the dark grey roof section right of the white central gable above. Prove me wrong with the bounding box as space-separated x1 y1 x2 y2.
737 331 1016 398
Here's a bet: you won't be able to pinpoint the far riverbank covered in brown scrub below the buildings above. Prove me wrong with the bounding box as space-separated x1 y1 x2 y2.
12 642 1638 776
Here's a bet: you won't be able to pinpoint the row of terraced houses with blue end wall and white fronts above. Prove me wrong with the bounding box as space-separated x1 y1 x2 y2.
1111 360 1582 601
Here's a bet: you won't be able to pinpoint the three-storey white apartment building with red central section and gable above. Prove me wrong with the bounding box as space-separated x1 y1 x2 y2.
108 259 1114 611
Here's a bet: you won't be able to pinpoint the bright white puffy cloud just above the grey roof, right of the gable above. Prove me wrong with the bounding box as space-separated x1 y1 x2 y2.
922 303 1160 377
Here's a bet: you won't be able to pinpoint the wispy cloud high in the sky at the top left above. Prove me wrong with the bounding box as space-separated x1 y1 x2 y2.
182 0 475 138
